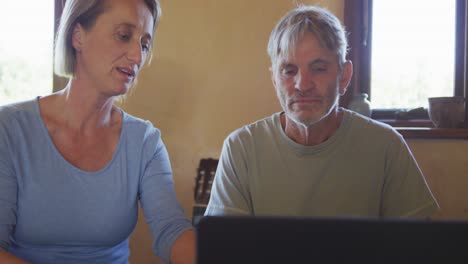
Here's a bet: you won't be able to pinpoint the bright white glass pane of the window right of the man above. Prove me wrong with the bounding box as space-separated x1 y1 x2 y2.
371 0 456 109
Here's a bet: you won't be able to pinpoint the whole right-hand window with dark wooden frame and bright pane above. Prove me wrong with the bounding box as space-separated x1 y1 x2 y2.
340 0 468 126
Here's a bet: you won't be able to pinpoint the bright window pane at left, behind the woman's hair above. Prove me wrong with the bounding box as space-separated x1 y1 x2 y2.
0 0 54 105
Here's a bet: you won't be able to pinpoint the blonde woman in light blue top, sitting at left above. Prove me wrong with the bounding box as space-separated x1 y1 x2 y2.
0 0 195 263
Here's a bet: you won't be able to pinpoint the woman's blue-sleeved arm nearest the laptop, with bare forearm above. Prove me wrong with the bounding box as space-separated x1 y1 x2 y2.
139 133 195 264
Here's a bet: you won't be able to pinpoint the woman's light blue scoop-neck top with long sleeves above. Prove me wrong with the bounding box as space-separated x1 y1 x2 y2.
0 99 192 264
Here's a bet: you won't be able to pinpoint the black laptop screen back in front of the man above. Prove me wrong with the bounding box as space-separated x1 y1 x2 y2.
196 216 468 264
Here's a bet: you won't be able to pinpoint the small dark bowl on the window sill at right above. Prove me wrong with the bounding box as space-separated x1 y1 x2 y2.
428 96 465 128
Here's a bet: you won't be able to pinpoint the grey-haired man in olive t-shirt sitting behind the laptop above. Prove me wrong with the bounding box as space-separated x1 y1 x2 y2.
205 6 438 217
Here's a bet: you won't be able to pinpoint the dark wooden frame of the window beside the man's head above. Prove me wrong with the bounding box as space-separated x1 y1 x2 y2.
340 0 468 127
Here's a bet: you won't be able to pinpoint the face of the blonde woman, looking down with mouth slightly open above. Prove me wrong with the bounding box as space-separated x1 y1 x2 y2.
73 0 153 96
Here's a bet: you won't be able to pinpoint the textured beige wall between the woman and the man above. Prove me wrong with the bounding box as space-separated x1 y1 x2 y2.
123 0 343 263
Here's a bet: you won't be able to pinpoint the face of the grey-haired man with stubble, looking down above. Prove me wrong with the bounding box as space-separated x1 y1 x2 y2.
272 33 350 126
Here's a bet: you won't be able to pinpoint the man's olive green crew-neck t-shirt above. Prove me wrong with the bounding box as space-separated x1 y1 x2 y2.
205 108 438 217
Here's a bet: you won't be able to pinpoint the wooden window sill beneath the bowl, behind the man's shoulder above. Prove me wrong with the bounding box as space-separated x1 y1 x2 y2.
379 119 468 139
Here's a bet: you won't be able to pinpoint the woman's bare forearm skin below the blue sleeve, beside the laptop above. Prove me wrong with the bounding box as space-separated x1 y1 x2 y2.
171 230 195 264
